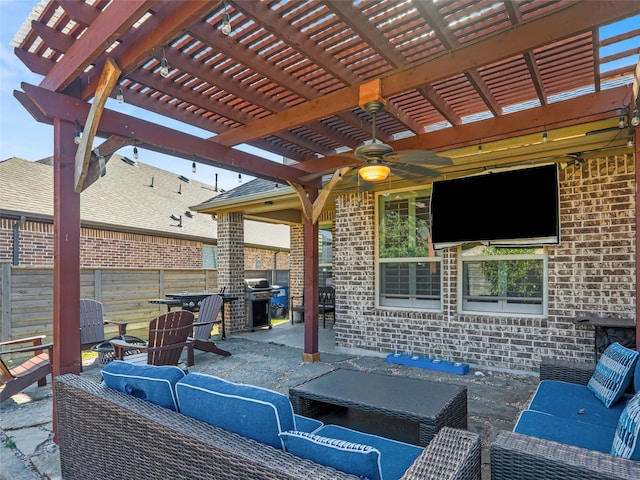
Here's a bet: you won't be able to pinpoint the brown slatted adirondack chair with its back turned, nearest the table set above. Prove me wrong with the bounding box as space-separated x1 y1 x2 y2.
110 310 195 367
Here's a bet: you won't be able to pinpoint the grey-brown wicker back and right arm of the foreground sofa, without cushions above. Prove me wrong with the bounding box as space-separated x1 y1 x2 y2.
54 374 480 480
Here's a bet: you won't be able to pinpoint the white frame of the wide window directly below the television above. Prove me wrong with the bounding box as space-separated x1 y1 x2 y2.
457 246 549 317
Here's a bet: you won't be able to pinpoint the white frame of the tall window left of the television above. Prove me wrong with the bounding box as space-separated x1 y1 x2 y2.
374 187 443 312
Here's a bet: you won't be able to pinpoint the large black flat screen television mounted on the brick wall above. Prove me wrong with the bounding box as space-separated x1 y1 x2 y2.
431 164 560 248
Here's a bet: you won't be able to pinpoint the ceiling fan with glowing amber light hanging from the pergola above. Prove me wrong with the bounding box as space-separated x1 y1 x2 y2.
344 100 453 182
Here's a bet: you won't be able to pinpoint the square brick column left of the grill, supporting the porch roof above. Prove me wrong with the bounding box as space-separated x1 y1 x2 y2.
218 212 245 333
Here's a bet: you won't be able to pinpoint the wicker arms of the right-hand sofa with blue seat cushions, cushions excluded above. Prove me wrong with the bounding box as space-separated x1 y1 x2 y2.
491 358 640 480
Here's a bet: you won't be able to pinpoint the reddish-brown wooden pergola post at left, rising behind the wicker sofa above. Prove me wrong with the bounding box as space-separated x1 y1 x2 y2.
52 119 82 443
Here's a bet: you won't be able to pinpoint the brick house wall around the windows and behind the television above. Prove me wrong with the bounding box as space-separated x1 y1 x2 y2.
330 155 636 371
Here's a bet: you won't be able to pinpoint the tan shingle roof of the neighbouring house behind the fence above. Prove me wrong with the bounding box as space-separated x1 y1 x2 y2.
0 155 289 248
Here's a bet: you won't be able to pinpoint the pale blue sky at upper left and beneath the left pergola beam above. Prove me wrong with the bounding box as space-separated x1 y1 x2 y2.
0 0 266 190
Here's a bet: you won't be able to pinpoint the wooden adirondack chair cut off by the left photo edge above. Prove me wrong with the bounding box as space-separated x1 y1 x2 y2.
0 335 53 402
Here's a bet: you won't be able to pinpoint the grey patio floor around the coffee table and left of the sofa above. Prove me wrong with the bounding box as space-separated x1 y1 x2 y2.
0 322 538 480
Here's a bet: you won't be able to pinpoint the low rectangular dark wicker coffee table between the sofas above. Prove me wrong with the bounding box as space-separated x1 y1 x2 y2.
289 369 467 446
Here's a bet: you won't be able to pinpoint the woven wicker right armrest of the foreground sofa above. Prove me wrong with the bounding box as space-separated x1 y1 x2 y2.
401 427 481 480
